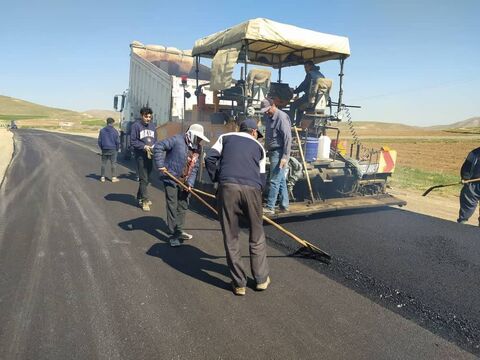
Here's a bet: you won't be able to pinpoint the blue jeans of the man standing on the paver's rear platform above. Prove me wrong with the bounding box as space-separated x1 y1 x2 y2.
267 150 288 209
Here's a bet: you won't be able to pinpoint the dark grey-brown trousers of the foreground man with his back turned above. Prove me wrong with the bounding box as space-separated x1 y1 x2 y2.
218 184 269 287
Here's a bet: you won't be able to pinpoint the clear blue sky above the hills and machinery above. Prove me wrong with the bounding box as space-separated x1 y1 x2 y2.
0 0 480 126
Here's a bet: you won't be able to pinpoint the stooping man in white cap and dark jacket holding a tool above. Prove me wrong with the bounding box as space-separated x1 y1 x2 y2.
155 124 210 246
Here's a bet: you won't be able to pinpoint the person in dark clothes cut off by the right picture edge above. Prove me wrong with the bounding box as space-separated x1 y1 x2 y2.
457 147 480 226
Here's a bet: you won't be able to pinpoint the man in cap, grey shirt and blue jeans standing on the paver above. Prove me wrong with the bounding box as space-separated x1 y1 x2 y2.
260 98 292 215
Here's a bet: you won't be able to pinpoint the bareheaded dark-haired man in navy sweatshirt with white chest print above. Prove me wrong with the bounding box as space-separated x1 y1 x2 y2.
130 107 155 211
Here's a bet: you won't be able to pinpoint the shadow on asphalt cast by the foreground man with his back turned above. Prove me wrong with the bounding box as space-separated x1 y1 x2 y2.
147 243 230 290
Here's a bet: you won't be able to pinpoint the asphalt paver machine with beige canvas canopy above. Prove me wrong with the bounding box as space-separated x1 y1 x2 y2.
192 18 406 217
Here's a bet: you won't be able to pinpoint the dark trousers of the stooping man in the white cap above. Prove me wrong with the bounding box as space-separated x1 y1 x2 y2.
163 182 190 235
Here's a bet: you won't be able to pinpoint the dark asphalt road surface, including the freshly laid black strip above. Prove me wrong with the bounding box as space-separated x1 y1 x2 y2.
0 130 480 359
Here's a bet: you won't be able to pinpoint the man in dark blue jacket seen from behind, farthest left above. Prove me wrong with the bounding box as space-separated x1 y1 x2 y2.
98 118 120 182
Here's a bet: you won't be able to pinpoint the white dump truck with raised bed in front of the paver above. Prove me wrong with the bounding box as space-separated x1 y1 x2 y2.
113 41 213 158
